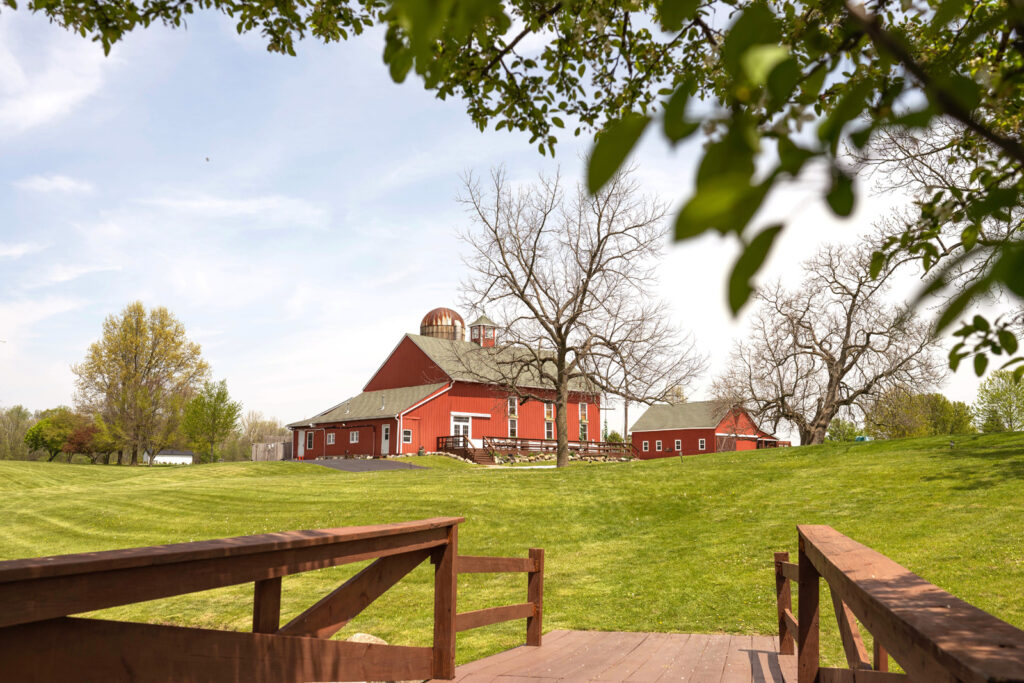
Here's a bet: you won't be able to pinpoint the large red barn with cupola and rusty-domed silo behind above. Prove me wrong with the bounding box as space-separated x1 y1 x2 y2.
288 308 601 460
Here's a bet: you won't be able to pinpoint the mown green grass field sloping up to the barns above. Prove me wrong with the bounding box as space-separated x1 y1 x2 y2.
0 434 1024 664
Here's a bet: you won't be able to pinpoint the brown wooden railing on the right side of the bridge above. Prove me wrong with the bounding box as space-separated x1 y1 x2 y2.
774 525 1024 683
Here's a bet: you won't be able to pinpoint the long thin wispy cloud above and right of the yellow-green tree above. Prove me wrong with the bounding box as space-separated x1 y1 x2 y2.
139 195 329 228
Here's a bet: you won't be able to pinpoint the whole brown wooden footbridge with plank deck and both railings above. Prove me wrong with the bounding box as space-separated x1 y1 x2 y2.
0 517 1024 683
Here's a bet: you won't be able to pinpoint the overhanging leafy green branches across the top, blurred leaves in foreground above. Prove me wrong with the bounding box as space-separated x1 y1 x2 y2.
9 0 1024 374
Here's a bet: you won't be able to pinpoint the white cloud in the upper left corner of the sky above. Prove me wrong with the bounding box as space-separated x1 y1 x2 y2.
0 13 104 136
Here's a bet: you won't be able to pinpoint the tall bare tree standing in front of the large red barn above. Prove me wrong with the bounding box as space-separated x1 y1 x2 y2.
461 169 703 467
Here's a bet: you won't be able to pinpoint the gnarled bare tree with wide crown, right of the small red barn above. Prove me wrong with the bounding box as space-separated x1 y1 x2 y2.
714 246 943 444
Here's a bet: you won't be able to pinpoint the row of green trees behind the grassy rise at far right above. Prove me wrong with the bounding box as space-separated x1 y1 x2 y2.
826 371 1024 441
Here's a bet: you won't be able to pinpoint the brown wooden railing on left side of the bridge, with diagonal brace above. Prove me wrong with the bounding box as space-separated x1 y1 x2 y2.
0 517 544 682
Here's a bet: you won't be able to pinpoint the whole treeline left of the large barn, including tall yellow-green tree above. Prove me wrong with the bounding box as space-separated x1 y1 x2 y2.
0 302 288 465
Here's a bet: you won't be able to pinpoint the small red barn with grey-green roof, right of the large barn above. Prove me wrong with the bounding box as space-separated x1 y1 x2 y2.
632 400 779 460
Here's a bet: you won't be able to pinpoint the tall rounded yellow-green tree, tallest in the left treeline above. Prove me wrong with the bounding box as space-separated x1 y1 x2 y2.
72 301 210 465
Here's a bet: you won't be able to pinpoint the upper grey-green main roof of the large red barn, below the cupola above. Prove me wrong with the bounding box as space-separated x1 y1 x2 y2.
407 334 597 393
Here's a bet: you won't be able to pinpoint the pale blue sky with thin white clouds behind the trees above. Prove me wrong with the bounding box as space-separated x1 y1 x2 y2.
0 9 1003 438
